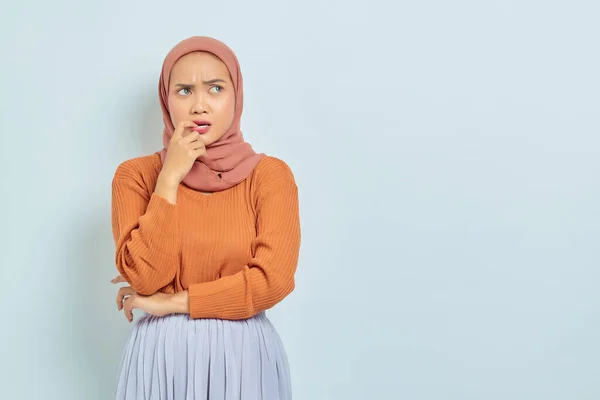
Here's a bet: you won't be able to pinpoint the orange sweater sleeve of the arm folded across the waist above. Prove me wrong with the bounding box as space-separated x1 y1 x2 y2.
188 160 300 319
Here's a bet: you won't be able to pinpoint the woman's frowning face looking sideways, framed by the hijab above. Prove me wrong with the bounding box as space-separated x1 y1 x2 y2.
168 52 235 146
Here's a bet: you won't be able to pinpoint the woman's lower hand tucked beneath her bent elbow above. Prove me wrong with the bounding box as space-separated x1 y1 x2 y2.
117 286 174 322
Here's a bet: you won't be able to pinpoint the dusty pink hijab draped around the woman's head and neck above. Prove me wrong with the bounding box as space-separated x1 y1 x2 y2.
158 36 264 192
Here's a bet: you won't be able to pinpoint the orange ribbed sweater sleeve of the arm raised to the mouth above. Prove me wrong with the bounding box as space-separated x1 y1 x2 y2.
112 162 179 295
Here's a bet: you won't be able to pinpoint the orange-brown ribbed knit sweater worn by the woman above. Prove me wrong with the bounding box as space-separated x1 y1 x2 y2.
112 154 300 319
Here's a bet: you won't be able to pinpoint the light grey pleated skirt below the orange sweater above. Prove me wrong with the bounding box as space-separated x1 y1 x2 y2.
116 313 292 400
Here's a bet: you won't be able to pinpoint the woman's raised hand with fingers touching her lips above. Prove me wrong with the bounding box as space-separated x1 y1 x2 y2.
159 121 206 185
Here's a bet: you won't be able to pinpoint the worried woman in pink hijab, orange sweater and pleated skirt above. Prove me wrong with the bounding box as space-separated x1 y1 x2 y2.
112 37 300 400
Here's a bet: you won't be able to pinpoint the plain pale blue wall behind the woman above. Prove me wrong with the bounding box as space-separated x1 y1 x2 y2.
0 0 600 400
